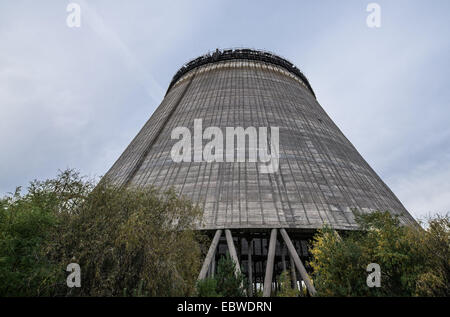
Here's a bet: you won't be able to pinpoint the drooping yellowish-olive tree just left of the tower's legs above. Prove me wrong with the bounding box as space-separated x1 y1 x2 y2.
48 183 201 296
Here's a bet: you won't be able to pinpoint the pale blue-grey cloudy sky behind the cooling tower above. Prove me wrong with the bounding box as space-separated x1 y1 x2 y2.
0 0 450 219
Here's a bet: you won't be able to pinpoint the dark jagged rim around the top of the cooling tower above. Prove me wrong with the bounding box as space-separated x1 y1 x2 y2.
166 48 316 98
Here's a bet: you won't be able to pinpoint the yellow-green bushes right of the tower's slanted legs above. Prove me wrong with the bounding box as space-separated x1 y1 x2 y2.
310 212 450 296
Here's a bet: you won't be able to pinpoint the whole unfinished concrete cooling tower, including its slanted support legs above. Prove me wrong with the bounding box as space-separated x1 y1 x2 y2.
105 49 415 296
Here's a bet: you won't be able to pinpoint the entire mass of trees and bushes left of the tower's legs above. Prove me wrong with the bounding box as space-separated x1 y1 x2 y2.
0 170 203 296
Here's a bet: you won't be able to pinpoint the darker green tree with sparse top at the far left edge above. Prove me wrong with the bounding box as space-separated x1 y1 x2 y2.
0 170 92 296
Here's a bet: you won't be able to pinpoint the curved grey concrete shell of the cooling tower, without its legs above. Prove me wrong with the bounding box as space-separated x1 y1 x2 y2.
106 49 414 296
